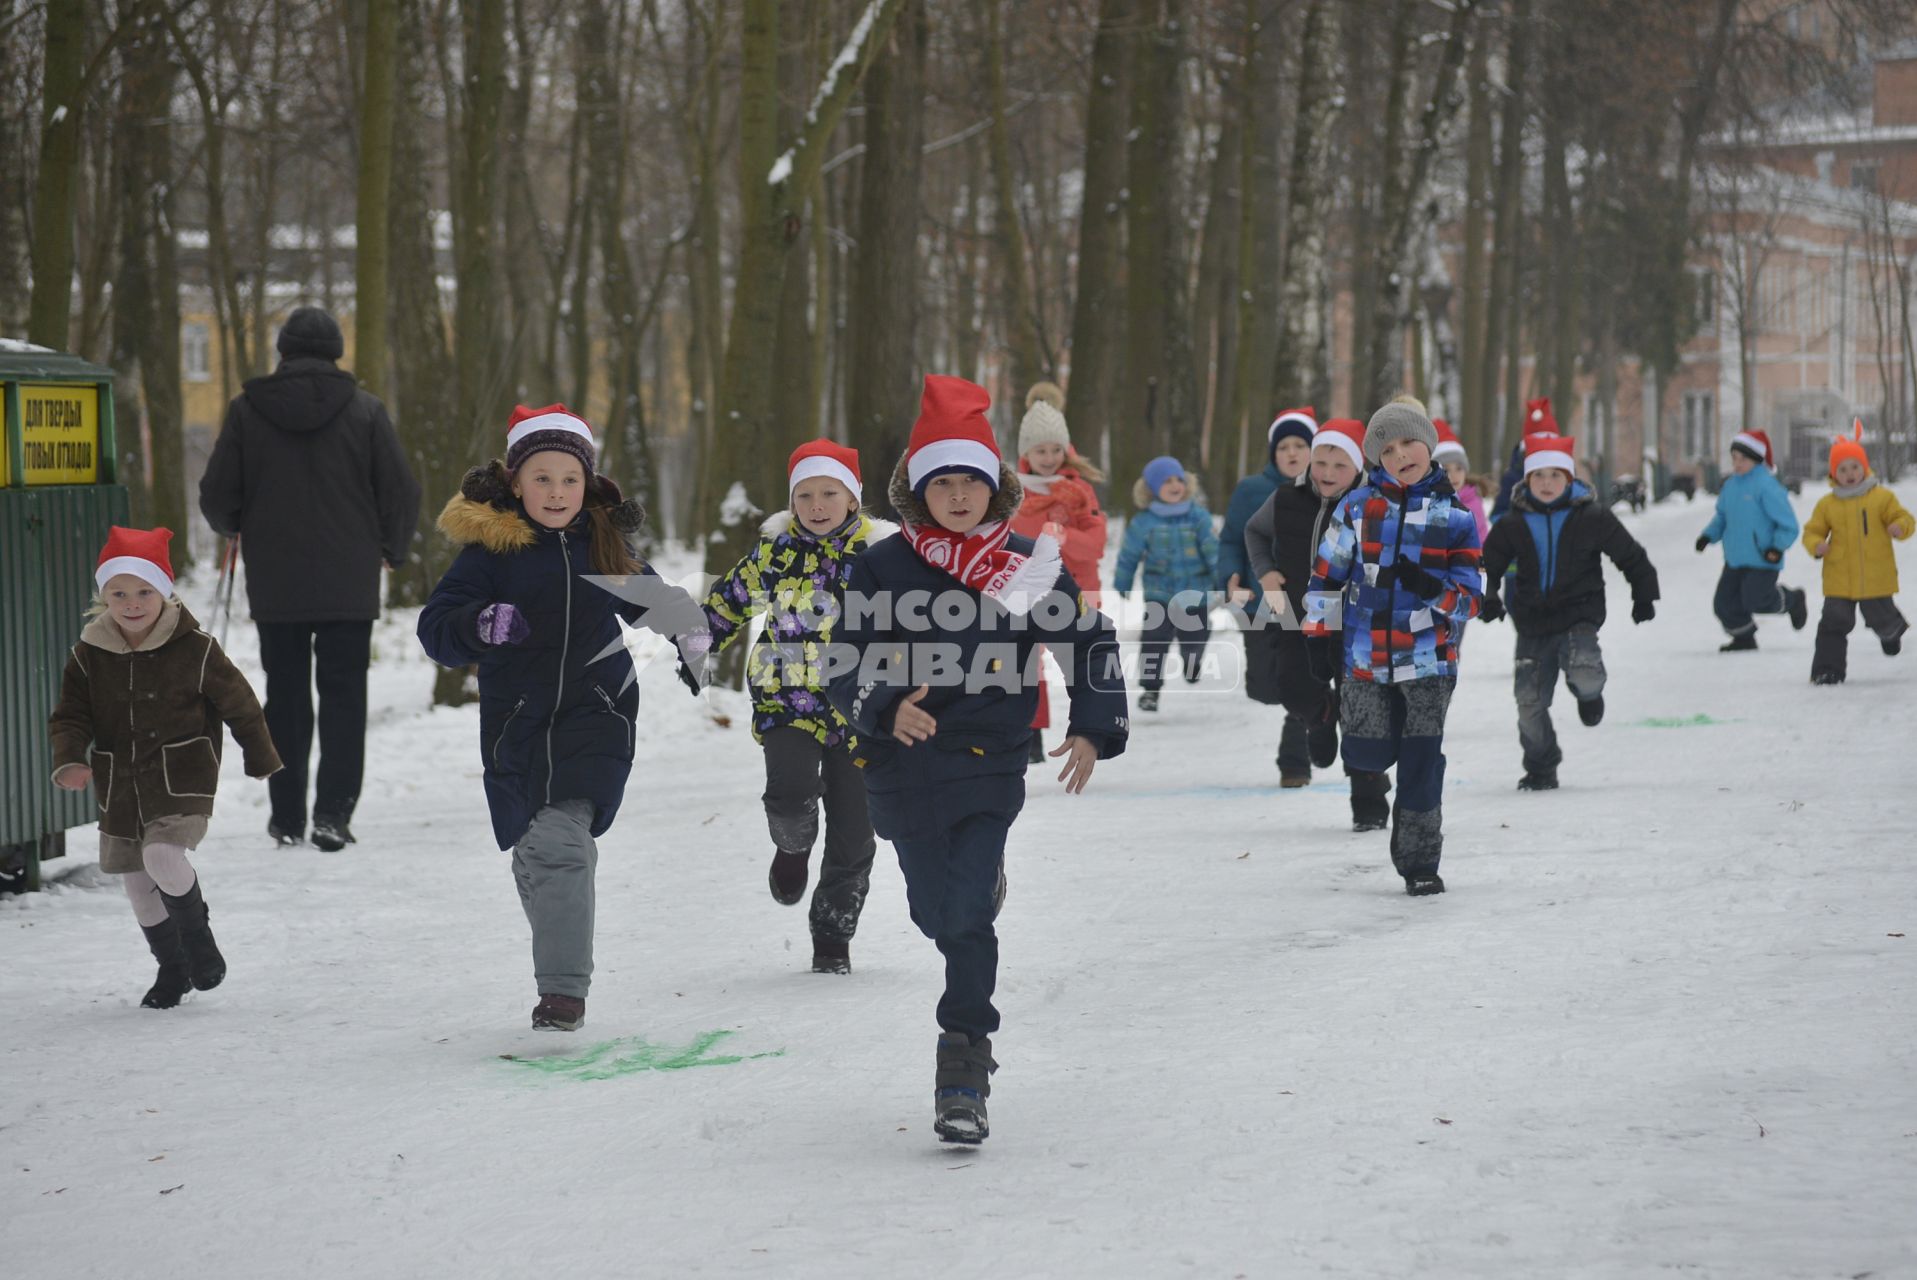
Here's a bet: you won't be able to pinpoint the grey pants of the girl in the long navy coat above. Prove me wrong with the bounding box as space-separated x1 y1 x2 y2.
512 799 598 1000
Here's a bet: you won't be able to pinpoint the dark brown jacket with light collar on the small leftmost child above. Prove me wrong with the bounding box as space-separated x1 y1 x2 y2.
48 602 280 841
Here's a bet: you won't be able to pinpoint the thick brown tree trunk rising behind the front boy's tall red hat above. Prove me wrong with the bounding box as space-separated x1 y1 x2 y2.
843 0 923 469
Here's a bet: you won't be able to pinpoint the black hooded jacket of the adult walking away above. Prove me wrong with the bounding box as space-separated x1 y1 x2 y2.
199 356 420 623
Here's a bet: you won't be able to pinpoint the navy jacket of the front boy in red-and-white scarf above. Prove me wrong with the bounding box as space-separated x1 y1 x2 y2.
828 466 1127 839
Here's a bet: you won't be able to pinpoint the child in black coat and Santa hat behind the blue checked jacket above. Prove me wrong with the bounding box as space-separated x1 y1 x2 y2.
1244 418 1392 832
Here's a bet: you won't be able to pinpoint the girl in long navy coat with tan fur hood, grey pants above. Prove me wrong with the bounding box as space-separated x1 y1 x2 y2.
418 404 704 1031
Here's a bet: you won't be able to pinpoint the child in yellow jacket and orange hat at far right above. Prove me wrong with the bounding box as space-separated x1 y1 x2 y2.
1804 422 1917 684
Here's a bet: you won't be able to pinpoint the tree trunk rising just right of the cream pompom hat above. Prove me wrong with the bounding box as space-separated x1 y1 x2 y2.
1070 0 1139 462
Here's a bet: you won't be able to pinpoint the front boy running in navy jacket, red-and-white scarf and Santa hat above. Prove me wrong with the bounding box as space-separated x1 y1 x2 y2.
830 376 1125 1142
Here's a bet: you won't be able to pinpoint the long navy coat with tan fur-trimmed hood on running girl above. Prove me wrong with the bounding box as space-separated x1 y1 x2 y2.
418 462 704 849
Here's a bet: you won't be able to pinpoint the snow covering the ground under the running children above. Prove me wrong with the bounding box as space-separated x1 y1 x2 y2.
0 498 1917 1280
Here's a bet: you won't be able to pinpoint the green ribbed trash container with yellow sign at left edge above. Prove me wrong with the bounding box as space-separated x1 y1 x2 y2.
0 343 127 893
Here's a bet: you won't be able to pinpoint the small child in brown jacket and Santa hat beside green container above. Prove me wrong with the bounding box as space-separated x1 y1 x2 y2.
48 525 280 1010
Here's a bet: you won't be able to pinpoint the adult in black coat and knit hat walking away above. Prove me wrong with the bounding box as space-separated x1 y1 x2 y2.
199 307 420 849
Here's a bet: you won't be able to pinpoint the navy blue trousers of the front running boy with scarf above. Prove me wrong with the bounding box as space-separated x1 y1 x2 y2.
891 809 1018 1040
